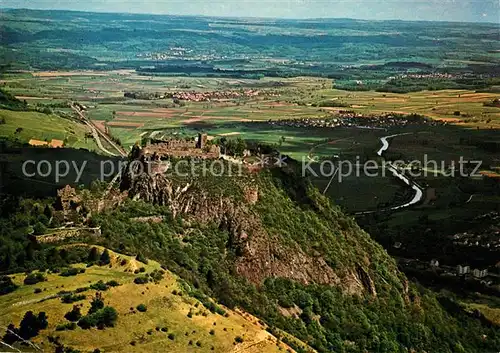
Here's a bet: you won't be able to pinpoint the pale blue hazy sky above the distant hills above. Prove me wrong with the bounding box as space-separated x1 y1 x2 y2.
0 0 500 23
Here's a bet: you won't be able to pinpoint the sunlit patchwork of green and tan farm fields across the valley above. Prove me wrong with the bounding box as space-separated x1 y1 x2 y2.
2 70 500 159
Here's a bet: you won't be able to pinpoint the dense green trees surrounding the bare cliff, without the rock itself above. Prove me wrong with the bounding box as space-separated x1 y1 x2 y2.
0 171 500 352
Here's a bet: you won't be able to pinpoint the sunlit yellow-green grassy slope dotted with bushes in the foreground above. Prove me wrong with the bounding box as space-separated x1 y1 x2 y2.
0 248 296 353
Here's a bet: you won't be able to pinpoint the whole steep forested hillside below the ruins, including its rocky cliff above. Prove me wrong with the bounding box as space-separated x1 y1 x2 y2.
0 164 500 352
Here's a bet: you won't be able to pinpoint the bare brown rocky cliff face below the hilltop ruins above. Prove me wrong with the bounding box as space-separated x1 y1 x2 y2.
121 164 390 295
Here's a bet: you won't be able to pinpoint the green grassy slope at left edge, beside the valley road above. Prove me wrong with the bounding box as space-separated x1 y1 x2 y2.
0 110 96 150
